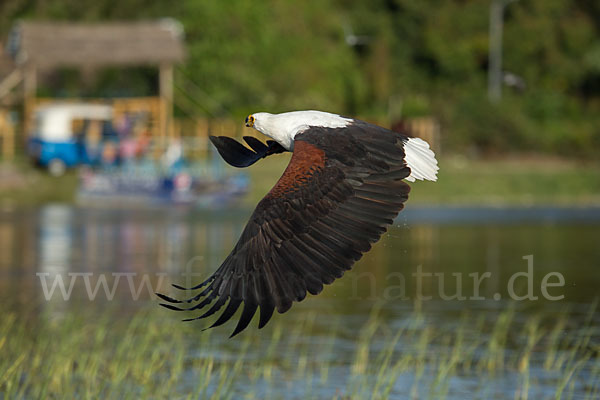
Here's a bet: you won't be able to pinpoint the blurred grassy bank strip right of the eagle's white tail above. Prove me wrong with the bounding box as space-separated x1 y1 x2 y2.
411 157 600 206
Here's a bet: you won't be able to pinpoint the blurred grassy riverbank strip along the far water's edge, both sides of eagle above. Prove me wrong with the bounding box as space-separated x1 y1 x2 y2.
0 155 600 208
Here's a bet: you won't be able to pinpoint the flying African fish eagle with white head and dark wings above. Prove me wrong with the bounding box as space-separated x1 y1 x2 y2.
158 111 438 336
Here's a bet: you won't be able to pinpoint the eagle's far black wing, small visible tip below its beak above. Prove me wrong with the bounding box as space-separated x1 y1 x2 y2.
209 136 287 168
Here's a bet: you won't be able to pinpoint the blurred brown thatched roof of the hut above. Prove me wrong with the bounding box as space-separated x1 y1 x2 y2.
8 19 185 68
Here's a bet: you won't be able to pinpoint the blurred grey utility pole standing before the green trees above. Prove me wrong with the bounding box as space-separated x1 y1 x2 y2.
488 0 518 103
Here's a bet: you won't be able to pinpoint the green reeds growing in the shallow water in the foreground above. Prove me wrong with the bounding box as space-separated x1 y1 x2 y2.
0 307 600 399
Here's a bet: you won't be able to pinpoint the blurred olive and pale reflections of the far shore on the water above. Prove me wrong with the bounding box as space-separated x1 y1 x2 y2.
0 206 600 396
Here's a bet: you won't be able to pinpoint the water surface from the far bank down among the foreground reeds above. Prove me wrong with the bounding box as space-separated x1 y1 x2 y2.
0 205 600 399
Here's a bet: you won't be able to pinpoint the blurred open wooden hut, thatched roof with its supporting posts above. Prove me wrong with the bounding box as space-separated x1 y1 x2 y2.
0 19 185 155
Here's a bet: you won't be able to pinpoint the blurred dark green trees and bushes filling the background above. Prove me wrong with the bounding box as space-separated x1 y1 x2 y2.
0 0 600 158
